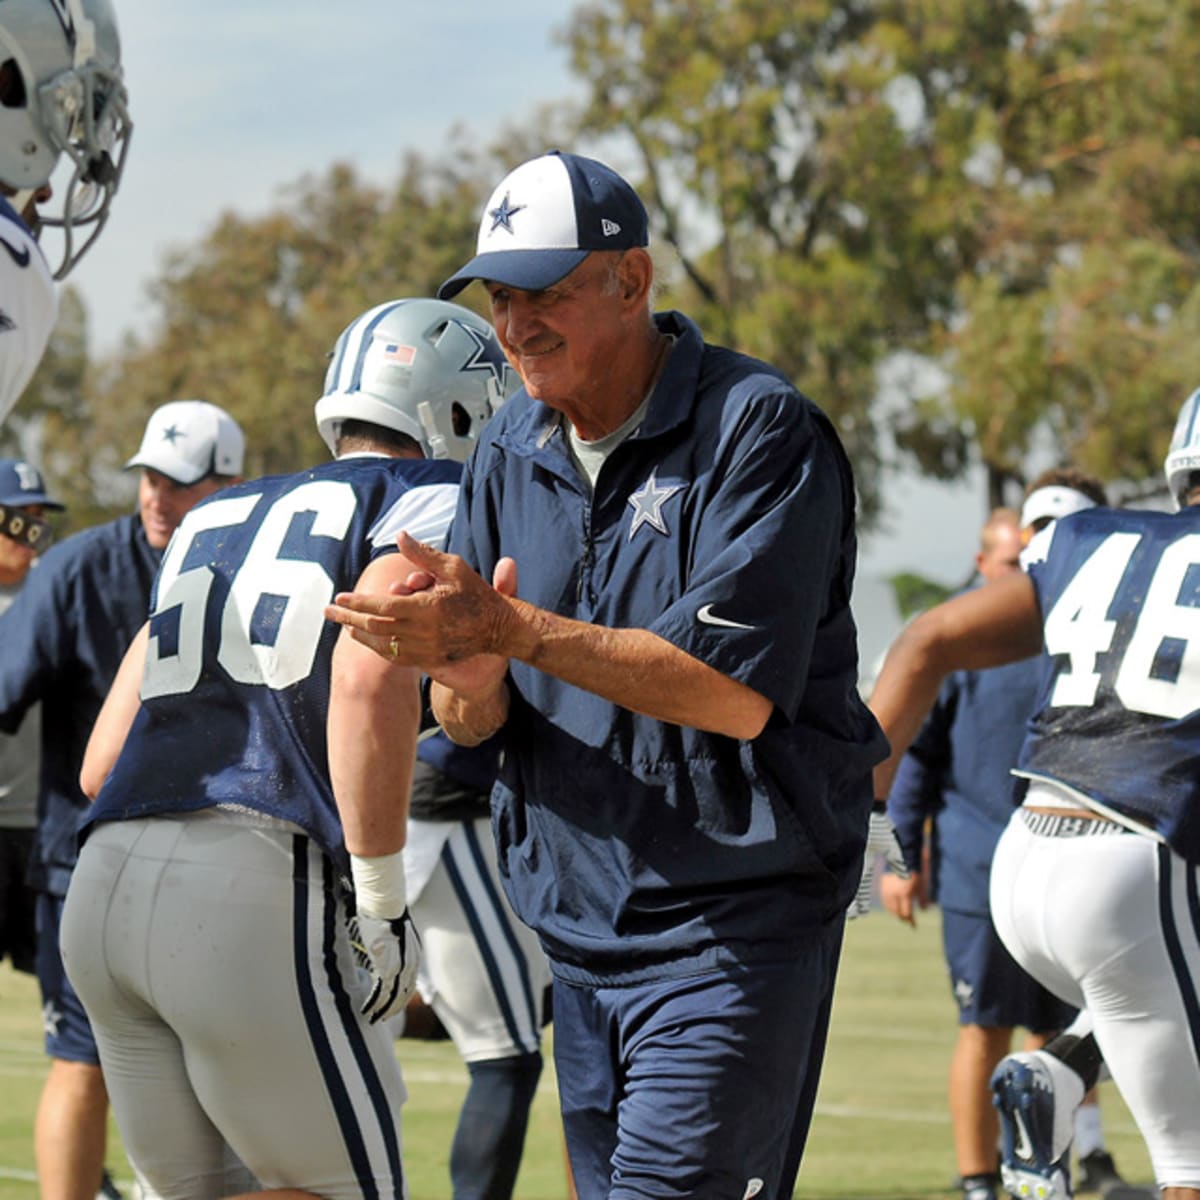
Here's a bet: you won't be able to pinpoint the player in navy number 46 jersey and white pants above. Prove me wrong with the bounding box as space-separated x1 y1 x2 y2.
871 391 1200 1200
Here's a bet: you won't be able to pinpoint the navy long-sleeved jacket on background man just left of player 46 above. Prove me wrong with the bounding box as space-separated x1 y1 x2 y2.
888 638 1042 914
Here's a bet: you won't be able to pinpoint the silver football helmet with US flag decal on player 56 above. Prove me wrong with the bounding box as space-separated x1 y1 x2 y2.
314 297 517 462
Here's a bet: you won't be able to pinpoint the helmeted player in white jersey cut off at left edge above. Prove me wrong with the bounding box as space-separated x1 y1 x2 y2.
0 0 132 421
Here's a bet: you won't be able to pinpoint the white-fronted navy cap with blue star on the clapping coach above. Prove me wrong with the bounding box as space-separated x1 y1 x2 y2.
438 150 650 300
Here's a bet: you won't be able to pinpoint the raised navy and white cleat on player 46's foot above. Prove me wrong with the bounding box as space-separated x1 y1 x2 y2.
991 1054 1072 1200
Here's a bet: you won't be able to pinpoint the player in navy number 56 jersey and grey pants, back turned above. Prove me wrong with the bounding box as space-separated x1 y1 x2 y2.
62 300 520 1200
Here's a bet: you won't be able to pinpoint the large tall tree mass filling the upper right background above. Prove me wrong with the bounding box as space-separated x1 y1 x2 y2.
565 0 1200 518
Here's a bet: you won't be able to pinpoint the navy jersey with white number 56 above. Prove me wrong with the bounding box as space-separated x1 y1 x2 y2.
91 456 461 870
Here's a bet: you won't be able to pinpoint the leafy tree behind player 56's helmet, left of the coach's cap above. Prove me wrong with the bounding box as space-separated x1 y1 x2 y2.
78 157 487 492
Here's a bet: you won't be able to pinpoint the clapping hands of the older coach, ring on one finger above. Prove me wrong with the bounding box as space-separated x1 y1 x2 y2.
325 533 516 692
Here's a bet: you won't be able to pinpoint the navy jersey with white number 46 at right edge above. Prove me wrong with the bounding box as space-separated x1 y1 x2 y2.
1016 508 1200 863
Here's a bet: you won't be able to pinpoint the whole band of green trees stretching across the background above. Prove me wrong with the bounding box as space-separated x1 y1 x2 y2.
10 0 1200 535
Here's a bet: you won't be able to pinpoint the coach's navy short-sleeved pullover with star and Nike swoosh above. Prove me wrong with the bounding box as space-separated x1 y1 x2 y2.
451 313 887 982
